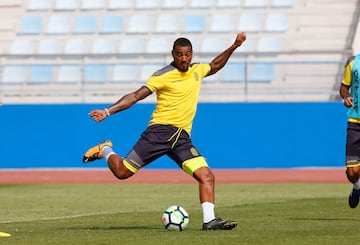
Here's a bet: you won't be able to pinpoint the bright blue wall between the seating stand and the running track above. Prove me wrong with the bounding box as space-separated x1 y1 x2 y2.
0 102 346 168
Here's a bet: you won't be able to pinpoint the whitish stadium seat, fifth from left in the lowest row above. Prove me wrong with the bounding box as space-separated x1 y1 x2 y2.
110 64 138 82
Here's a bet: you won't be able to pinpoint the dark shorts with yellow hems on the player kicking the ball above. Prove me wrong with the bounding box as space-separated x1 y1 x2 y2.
124 124 207 175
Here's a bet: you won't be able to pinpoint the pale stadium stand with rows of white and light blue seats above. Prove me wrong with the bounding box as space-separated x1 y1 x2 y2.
0 0 359 103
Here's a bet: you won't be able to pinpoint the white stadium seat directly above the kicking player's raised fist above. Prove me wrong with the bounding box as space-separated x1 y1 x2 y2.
237 13 264 32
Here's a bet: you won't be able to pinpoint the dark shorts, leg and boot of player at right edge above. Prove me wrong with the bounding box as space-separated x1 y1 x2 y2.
346 123 360 208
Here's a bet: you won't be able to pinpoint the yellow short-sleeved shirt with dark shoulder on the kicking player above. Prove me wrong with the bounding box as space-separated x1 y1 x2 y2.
145 64 211 134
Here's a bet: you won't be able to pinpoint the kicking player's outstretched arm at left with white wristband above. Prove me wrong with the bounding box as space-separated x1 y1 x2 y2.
89 86 152 122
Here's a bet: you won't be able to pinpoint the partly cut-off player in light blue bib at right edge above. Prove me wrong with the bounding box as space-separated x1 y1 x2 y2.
340 54 360 208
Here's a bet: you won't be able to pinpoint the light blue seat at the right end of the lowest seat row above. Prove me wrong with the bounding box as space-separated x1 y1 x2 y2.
249 63 274 82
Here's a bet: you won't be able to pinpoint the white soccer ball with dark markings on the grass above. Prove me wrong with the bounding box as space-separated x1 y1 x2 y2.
162 205 189 231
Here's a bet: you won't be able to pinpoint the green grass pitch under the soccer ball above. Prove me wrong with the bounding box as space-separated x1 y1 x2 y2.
0 184 360 245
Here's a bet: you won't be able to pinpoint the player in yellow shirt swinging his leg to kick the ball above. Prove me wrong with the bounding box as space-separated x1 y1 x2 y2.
83 32 246 230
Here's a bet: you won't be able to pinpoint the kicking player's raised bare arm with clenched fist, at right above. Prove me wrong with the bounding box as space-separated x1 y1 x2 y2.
207 32 246 76
